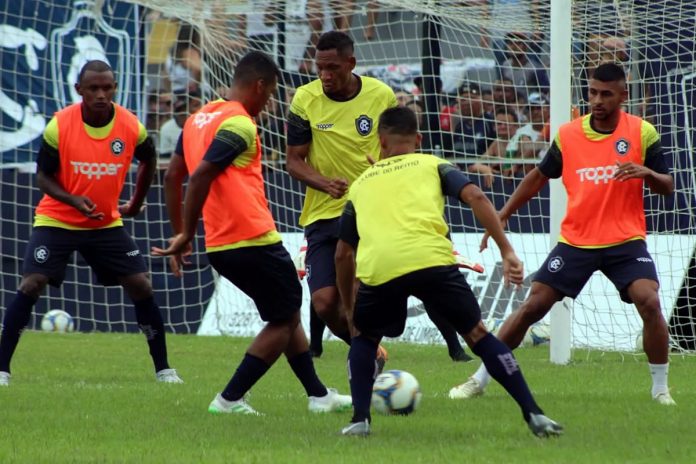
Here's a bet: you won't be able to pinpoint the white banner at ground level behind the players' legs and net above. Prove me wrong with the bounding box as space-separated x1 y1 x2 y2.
198 233 696 351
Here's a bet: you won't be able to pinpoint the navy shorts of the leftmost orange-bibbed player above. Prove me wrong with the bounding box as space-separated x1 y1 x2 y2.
22 226 148 287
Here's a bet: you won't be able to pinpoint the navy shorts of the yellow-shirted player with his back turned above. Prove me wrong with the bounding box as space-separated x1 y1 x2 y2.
353 266 481 337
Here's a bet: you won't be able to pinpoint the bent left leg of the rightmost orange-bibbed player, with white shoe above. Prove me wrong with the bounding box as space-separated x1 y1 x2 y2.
450 243 601 399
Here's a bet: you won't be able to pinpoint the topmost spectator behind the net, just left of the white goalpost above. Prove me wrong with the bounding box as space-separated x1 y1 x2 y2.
500 32 549 100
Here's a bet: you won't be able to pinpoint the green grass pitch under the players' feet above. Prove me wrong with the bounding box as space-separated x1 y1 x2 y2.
0 332 696 464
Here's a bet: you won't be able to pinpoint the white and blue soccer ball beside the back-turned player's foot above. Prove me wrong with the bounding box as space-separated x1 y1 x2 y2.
372 370 422 415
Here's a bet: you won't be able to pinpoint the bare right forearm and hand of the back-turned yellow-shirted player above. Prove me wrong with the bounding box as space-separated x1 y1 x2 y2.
459 184 524 286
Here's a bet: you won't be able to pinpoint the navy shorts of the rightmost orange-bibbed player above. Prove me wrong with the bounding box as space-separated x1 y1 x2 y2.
532 240 659 303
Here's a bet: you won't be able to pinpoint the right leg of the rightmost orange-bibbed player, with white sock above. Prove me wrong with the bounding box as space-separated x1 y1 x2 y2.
602 240 676 406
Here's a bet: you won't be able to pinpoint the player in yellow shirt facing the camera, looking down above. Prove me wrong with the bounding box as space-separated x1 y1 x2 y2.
287 31 470 369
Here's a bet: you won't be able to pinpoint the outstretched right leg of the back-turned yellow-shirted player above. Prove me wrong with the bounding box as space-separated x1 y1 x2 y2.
415 266 562 436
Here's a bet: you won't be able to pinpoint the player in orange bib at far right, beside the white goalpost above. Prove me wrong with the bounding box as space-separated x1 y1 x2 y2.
450 63 676 405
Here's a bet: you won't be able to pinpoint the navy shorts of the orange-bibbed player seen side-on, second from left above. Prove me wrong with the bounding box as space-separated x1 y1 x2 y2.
208 243 302 322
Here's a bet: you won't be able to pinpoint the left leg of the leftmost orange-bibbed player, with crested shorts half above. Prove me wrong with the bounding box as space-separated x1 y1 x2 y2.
0 227 74 386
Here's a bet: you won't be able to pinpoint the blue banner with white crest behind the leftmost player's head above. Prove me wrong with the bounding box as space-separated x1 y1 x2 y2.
0 0 144 163
